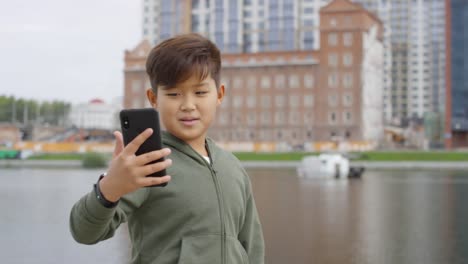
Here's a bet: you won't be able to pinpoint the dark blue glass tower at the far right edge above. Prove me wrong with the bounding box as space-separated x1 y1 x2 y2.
445 0 468 148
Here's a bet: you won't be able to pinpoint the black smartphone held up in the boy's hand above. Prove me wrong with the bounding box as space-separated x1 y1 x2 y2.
120 108 167 187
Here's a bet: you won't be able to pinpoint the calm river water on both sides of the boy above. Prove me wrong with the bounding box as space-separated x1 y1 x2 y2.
0 168 468 264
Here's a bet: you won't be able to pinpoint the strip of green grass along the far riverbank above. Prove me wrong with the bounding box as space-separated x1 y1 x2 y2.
0 160 468 170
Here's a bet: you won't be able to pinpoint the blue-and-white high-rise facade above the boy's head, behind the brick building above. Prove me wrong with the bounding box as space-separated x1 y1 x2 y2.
142 0 330 53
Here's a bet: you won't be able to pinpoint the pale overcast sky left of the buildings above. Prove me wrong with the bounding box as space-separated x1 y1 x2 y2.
0 0 141 103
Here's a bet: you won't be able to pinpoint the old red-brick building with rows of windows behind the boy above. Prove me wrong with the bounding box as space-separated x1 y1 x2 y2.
124 0 383 146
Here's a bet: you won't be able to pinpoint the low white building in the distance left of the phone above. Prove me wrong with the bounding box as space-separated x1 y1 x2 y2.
70 99 122 130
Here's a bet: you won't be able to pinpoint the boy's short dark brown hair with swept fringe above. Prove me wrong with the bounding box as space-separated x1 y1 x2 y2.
146 33 221 92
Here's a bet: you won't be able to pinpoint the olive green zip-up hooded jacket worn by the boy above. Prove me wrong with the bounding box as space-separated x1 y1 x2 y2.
70 132 264 264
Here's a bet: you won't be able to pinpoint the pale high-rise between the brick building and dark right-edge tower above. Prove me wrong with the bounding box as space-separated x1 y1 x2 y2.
355 0 445 121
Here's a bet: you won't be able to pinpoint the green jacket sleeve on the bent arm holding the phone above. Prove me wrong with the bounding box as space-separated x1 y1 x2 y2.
70 188 148 245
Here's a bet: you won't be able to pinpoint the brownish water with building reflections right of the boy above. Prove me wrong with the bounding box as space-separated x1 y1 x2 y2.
250 168 468 264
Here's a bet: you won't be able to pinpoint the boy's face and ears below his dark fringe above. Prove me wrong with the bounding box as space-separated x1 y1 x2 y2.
147 75 224 146
